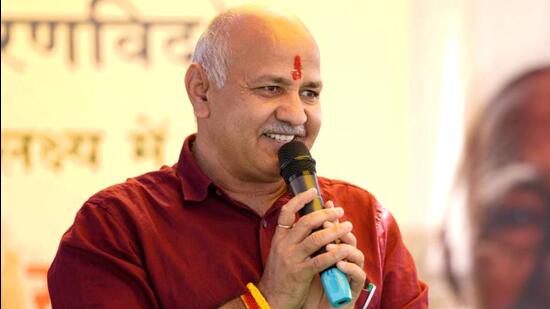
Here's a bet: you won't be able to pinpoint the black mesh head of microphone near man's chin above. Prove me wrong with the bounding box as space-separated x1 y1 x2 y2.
279 141 316 183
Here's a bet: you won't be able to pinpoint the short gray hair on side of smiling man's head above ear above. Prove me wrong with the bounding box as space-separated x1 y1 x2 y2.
193 10 237 89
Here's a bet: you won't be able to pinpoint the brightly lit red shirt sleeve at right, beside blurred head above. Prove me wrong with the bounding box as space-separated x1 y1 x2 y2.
380 209 428 308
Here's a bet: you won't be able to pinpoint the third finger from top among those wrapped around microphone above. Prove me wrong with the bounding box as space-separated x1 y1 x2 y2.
297 220 353 256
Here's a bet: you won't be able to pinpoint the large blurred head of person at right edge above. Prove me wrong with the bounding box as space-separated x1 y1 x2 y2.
447 65 550 308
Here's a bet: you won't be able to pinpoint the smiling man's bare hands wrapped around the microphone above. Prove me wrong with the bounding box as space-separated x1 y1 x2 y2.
258 189 365 308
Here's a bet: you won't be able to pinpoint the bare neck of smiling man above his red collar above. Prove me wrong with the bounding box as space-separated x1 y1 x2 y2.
191 135 287 216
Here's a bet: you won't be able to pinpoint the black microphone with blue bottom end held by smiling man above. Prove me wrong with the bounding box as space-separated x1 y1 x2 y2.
279 141 351 308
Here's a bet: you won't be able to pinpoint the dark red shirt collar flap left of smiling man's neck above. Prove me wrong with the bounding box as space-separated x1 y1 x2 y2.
176 134 212 202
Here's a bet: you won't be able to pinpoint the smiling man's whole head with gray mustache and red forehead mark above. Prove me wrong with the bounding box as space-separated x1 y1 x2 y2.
185 6 322 185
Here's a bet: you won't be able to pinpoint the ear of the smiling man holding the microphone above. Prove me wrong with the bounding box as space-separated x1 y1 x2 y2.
185 63 210 118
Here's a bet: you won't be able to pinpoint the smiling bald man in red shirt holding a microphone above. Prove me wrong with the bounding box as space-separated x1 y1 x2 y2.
48 6 427 308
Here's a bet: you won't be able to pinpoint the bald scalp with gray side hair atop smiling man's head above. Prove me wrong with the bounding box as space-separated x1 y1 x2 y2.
193 4 317 88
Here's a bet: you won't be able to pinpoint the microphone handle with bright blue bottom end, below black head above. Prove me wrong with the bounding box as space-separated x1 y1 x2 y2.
288 170 351 308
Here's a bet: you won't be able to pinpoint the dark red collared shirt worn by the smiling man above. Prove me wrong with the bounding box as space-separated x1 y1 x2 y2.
48 136 428 308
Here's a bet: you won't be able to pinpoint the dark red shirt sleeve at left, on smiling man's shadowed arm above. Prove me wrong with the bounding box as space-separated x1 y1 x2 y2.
48 202 159 308
